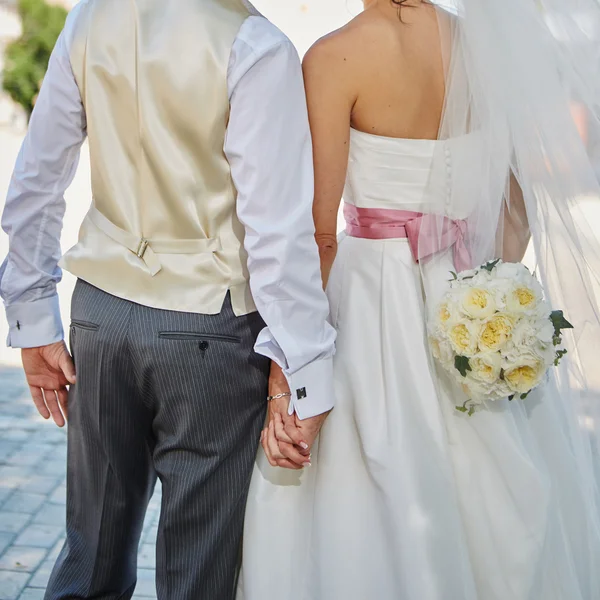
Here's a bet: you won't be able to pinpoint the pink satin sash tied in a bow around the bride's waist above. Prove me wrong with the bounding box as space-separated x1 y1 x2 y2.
344 203 471 271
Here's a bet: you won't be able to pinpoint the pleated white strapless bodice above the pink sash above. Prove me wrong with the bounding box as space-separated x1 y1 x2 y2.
344 129 475 219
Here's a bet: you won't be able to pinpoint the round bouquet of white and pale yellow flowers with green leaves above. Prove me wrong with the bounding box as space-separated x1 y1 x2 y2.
429 260 573 416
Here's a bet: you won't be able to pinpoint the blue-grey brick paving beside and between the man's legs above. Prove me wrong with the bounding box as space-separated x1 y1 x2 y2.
0 367 160 600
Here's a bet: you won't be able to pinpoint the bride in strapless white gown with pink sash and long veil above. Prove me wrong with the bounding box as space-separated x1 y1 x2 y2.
238 0 600 600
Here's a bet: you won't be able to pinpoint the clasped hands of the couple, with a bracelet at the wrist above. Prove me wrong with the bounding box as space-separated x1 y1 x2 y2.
261 363 329 470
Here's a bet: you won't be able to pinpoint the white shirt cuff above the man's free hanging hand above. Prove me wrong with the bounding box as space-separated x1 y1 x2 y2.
6 294 64 348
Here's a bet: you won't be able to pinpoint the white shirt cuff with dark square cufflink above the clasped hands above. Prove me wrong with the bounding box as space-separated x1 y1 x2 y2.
285 357 335 421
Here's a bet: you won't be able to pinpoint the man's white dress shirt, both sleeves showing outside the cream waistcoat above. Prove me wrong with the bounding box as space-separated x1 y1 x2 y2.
0 7 335 419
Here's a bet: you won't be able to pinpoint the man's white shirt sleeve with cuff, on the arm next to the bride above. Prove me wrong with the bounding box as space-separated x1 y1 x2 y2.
225 32 336 419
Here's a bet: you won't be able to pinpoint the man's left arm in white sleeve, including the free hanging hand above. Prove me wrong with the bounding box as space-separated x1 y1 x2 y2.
0 17 85 426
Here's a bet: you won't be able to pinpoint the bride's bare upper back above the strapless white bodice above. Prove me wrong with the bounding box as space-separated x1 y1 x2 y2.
322 0 445 139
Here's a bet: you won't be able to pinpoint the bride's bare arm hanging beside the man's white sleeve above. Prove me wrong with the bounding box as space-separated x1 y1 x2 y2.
303 35 355 286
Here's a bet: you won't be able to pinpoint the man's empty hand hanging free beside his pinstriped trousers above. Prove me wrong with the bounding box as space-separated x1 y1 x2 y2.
21 342 75 427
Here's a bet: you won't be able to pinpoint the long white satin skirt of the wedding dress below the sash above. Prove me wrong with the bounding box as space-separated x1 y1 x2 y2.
237 238 600 600
